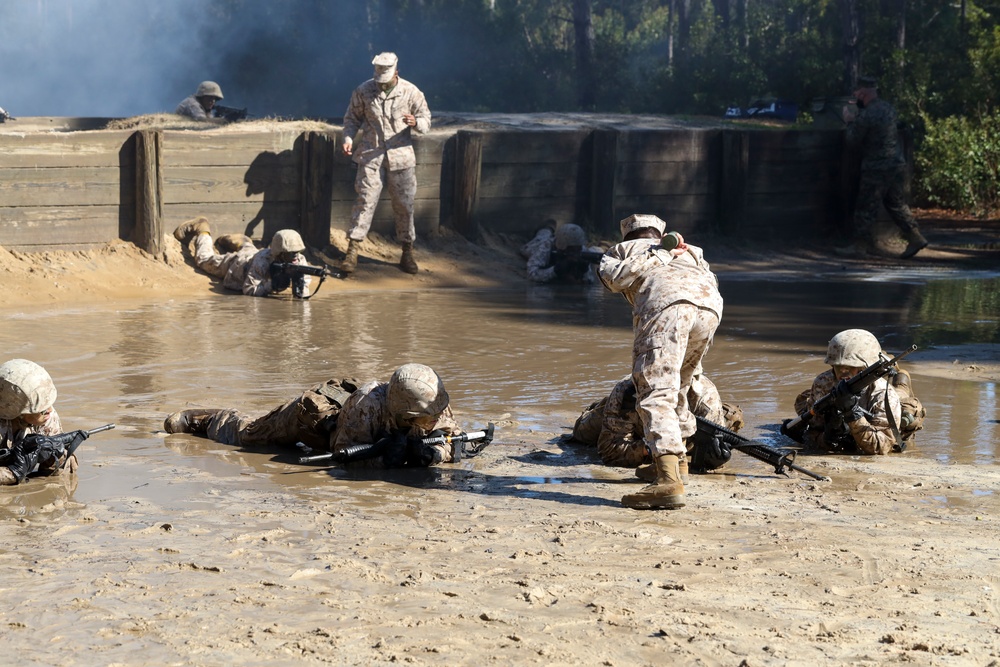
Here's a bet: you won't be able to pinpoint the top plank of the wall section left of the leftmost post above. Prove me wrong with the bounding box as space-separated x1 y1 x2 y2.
0 131 135 170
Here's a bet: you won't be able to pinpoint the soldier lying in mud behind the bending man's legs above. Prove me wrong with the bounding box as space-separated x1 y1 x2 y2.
570 373 743 482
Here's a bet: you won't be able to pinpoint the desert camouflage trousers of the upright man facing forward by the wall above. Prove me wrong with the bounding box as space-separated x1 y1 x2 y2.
347 157 417 243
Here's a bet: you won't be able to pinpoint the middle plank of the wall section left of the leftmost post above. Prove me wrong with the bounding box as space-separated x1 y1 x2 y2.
0 165 127 206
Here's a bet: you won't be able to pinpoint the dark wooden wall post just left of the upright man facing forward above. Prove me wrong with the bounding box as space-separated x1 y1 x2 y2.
299 132 337 250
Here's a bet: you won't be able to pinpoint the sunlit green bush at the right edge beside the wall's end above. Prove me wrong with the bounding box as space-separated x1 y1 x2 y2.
914 112 1000 216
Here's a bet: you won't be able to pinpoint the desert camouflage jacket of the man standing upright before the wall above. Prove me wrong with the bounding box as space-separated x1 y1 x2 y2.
344 79 431 171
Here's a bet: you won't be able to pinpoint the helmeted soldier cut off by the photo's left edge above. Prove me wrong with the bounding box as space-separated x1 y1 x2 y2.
0 359 77 486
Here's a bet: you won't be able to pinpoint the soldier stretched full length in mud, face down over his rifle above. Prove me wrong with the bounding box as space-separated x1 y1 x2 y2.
163 364 484 468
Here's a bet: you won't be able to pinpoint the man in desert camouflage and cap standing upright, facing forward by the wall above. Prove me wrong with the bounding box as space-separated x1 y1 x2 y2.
340 53 431 273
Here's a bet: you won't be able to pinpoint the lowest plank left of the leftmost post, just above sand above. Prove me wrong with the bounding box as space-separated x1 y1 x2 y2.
0 206 119 248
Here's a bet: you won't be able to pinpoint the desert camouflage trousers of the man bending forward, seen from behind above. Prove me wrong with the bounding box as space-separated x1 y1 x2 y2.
632 302 719 456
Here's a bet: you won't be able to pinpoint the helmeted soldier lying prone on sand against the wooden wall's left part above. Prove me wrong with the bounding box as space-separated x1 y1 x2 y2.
174 217 309 296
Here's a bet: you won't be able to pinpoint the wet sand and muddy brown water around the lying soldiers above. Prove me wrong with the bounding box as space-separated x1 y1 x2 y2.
0 226 1000 665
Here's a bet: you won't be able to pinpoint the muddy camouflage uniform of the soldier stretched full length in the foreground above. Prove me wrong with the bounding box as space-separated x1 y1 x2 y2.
206 379 461 463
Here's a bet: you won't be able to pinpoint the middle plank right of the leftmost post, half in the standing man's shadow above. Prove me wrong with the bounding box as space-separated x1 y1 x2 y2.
163 164 302 204
